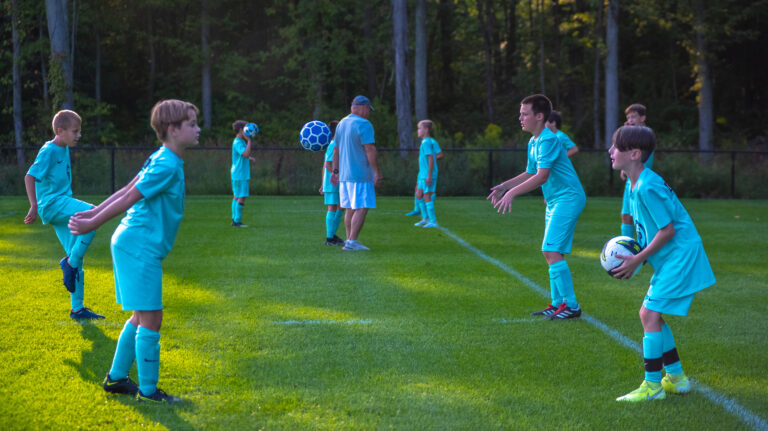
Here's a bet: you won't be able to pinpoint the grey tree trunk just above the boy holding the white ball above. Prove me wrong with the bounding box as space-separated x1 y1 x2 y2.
604 0 619 148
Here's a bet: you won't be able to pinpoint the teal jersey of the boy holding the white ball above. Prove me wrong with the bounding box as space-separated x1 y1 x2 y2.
629 169 715 298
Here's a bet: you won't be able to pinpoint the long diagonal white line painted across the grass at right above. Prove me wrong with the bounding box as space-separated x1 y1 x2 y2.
438 226 768 431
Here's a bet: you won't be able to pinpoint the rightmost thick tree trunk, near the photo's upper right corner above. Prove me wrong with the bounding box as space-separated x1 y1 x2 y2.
696 0 714 162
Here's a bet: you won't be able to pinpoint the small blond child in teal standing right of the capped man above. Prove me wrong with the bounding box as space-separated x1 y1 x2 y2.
415 120 443 228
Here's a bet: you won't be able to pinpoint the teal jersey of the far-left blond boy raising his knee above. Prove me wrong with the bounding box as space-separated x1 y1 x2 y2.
27 141 72 224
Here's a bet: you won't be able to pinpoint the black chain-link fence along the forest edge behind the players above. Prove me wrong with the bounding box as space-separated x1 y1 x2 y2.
0 146 768 199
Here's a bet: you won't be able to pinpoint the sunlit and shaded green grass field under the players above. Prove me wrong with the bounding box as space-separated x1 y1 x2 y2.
0 196 768 430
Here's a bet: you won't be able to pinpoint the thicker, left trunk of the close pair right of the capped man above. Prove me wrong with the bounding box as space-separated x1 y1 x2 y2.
392 0 413 156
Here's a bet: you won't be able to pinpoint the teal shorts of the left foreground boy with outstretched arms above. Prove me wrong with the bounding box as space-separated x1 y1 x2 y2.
111 243 163 311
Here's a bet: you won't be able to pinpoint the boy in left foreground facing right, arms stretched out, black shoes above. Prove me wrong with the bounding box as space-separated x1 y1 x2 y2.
69 100 200 403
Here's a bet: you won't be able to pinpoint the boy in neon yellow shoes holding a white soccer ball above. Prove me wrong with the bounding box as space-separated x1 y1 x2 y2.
608 126 715 402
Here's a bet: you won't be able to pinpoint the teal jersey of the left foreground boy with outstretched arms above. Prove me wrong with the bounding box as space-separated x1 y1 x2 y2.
112 146 185 259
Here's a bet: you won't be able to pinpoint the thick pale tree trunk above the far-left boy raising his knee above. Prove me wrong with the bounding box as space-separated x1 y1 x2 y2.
45 0 75 109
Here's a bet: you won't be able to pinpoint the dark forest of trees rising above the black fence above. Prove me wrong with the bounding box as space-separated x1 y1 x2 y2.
0 0 768 165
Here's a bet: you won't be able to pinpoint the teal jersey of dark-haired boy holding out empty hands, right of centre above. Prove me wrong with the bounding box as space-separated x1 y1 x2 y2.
525 128 586 215
